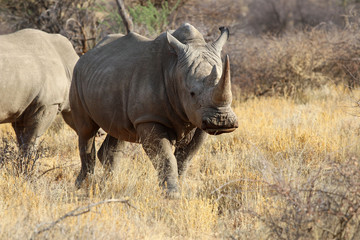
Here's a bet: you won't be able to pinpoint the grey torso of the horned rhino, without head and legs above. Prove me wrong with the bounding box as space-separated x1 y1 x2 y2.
70 33 171 141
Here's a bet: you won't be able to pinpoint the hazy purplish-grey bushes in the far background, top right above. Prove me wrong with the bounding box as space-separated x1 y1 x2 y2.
246 0 359 34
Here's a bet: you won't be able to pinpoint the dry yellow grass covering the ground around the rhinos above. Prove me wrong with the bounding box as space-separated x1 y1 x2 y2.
0 84 360 239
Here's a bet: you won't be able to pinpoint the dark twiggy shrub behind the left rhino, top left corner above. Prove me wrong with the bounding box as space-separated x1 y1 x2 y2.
0 0 97 55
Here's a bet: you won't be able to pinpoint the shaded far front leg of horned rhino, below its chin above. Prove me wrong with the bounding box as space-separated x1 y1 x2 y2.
175 128 207 176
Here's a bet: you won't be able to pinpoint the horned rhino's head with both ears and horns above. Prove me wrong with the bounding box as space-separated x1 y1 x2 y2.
167 24 238 135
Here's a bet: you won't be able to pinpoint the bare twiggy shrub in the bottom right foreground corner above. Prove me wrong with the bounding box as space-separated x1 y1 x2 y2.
250 158 360 239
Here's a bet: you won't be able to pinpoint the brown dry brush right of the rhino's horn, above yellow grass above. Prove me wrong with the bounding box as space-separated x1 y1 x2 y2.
232 28 360 98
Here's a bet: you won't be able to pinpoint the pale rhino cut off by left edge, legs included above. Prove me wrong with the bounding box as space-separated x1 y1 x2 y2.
0 29 79 153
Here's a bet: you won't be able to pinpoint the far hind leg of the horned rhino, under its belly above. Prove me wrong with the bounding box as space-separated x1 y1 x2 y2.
97 134 125 171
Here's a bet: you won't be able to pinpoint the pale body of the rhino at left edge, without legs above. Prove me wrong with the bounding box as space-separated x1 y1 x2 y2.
0 29 78 122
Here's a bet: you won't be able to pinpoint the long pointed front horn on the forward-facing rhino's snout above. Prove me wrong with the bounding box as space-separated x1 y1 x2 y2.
212 55 232 105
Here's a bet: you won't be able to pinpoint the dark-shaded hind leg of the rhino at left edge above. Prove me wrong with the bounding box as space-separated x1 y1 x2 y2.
12 104 58 171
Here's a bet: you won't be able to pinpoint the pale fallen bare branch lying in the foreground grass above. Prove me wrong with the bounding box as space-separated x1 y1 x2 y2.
30 199 137 240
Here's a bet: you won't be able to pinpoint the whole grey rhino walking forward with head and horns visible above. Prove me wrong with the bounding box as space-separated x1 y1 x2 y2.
70 24 238 197
